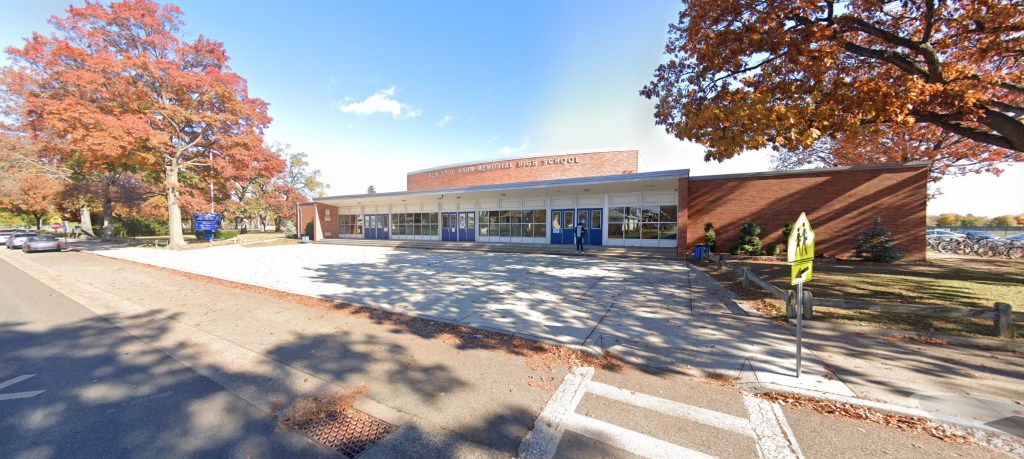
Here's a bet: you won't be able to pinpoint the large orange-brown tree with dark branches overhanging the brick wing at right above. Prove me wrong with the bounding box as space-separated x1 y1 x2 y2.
640 0 1024 162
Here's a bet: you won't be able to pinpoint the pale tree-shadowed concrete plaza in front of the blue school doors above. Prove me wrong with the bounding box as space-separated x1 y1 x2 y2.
88 245 854 395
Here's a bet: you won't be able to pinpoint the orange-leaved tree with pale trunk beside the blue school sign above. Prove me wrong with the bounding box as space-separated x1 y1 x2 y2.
3 0 270 248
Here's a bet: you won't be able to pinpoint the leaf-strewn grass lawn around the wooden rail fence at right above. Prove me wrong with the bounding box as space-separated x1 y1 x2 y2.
709 252 1024 340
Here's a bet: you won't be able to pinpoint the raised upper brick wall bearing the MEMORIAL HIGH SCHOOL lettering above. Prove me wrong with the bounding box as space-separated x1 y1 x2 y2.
406 150 638 192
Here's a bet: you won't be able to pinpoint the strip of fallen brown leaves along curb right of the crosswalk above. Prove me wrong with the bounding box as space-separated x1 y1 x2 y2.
758 392 979 446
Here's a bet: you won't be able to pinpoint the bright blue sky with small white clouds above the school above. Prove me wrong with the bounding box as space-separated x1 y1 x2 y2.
0 0 1024 216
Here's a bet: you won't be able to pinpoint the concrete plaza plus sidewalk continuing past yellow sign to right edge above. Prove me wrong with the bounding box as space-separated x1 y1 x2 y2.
79 239 1024 436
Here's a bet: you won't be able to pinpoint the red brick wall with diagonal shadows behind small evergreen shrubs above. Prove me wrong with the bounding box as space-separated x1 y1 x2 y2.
679 165 928 260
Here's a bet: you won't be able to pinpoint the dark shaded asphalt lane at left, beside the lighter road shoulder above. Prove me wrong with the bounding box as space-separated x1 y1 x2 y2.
0 254 336 458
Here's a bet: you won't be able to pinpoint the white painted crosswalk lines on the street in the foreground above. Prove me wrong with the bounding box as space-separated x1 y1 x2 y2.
519 368 803 459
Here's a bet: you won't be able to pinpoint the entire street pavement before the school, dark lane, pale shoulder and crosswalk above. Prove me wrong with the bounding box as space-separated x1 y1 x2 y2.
0 247 1004 458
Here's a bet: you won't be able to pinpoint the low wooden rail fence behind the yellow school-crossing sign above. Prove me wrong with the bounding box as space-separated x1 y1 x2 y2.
709 255 1024 338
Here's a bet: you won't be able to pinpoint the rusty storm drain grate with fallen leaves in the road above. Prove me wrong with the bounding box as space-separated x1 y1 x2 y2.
301 409 394 458
